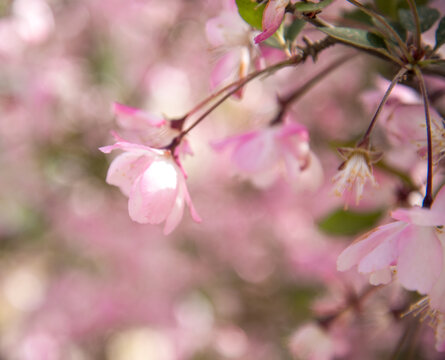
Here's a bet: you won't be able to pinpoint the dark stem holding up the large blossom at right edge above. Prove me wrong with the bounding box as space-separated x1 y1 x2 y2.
414 66 433 208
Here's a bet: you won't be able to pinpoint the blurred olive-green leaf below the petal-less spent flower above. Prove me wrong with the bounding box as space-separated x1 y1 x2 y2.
318 209 383 236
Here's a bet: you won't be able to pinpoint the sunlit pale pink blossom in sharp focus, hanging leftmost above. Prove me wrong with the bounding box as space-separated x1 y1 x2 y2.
100 137 201 234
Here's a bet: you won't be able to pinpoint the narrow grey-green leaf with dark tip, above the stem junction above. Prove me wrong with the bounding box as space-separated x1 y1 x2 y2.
318 27 389 55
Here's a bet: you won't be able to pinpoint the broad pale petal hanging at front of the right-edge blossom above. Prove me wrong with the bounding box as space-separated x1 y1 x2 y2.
397 226 443 294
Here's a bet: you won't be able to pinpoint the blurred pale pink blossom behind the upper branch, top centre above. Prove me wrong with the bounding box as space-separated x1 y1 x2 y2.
206 11 261 97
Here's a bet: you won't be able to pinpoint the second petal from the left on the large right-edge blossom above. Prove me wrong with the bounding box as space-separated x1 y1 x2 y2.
357 224 415 274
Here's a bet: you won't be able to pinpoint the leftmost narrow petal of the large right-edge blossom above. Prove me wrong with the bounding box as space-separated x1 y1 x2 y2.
337 221 406 271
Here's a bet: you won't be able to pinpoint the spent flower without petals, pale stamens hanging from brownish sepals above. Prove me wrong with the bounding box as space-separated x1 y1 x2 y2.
332 148 381 205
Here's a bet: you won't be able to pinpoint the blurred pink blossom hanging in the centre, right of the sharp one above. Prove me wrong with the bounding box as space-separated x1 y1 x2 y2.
213 122 321 187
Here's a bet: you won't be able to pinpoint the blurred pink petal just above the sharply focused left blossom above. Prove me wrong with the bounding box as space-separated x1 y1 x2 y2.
113 103 166 130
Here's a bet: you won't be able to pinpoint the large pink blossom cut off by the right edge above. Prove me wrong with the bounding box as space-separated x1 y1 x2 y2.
337 187 445 313
